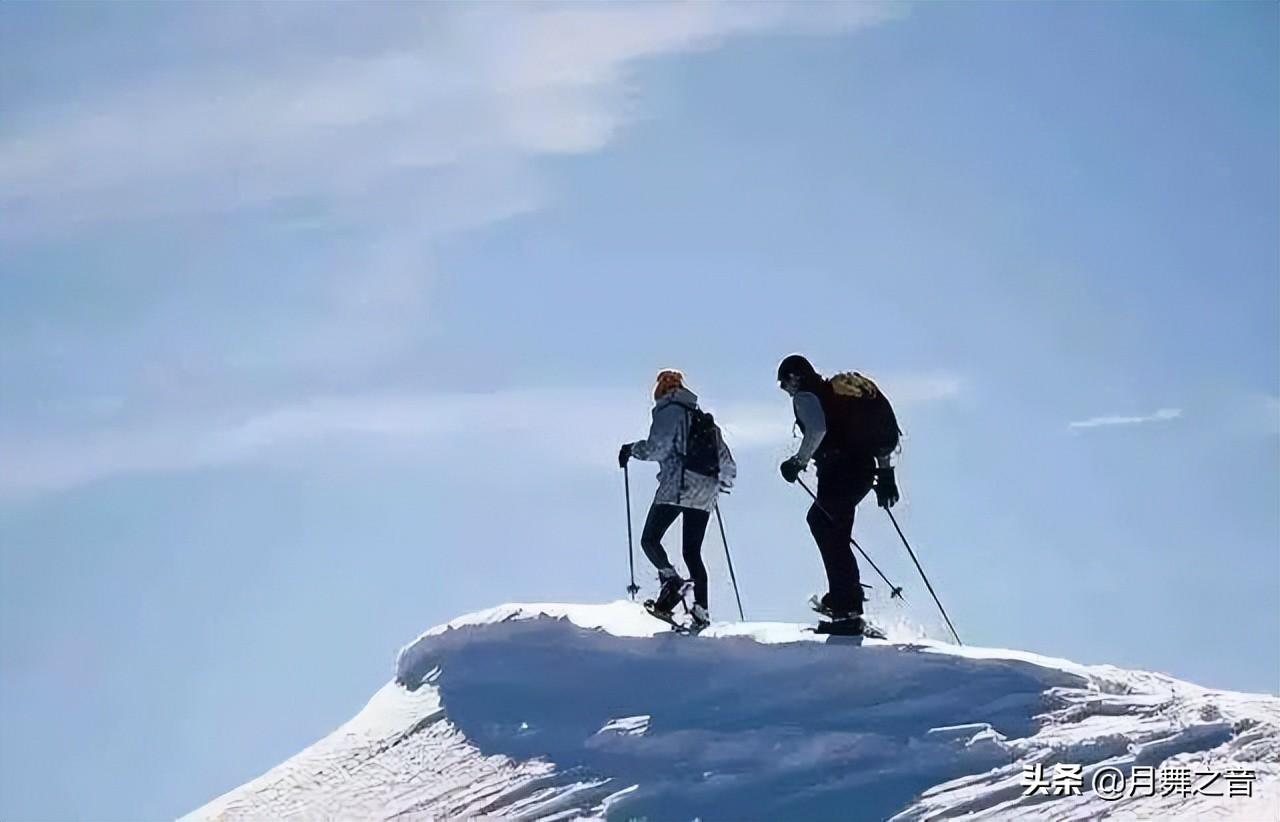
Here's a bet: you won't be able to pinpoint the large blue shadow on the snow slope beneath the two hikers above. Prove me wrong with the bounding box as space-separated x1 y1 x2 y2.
397 617 1084 819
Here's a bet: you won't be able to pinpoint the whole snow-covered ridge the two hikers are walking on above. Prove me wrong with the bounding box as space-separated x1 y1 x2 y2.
188 602 1280 821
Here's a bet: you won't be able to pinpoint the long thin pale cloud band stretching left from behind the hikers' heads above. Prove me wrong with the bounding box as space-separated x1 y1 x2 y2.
0 375 961 497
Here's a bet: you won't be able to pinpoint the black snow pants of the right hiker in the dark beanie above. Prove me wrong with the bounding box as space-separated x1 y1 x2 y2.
806 460 876 612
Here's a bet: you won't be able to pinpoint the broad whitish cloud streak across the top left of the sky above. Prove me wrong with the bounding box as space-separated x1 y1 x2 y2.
0 3 893 232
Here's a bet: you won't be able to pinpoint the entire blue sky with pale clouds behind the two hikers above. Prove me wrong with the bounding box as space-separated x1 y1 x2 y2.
0 3 1280 819
